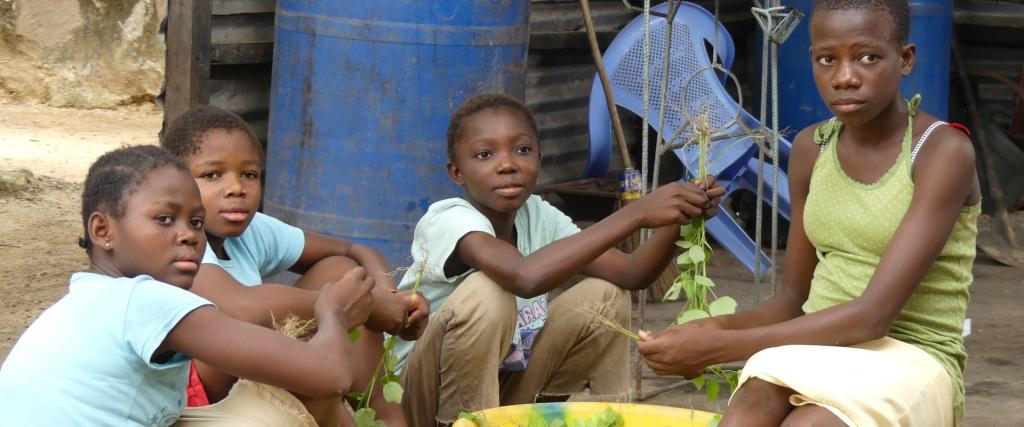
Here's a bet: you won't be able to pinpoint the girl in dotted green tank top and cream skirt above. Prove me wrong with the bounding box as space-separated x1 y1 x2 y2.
638 0 981 426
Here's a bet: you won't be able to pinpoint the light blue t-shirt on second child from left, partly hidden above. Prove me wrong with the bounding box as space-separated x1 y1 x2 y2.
203 212 306 286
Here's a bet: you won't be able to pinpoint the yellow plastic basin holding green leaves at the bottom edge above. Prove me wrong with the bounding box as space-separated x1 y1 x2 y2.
460 401 715 427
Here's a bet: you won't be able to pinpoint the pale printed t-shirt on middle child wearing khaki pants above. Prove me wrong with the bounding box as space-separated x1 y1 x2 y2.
394 196 580 371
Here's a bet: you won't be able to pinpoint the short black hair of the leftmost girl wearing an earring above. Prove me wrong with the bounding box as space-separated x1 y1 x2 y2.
78 145 188 255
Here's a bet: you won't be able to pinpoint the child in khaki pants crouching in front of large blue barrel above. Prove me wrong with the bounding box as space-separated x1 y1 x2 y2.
395 94 724 421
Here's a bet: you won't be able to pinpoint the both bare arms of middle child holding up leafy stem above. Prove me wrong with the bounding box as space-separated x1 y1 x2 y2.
454 182 721 298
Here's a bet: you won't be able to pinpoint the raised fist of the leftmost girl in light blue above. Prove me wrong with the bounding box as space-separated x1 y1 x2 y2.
314 267 374 331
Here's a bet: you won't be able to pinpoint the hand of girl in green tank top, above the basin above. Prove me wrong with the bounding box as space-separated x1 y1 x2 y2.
637 325 716 379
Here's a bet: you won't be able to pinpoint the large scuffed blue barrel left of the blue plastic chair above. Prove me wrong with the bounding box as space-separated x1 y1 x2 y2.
263 0 529 266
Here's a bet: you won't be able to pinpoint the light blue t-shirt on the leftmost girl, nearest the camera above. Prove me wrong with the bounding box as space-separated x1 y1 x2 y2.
0 272 211 426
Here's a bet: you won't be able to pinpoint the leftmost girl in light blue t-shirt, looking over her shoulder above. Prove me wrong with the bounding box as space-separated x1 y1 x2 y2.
0 145 374 426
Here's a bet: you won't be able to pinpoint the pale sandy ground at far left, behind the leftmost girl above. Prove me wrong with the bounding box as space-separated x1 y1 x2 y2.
0 104 163 358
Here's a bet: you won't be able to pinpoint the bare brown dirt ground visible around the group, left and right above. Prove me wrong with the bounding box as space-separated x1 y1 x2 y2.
0 104 1024 426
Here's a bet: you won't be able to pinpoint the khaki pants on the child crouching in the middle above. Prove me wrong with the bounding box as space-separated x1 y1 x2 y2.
401 272 630 427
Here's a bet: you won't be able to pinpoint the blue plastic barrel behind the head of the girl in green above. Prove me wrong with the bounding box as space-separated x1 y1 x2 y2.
778 0 953 133
